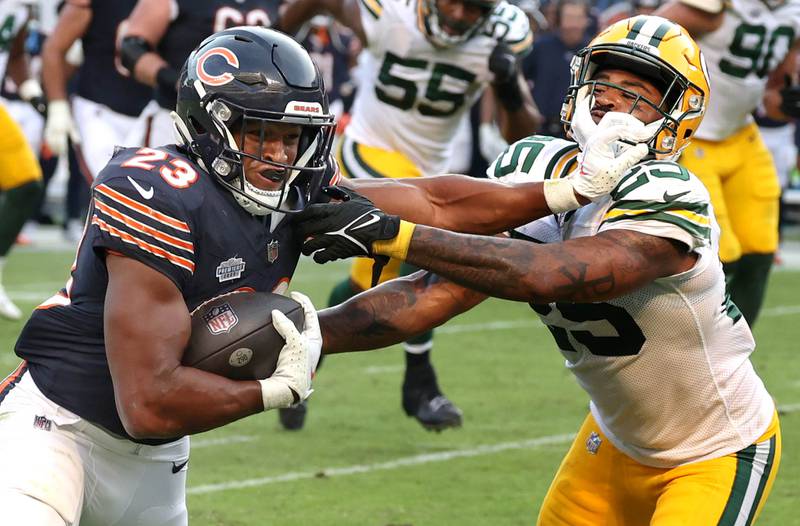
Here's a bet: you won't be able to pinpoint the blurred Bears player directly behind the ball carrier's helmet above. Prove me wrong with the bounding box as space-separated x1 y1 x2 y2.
119 0 281 151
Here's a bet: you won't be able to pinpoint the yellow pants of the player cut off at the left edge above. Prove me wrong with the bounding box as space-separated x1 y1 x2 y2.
0 104 42 192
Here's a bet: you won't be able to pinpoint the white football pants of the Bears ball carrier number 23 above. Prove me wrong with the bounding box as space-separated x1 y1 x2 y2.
0 372 189 526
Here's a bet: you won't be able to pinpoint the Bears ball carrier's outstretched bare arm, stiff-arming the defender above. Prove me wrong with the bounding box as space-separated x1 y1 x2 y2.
343 175 550 235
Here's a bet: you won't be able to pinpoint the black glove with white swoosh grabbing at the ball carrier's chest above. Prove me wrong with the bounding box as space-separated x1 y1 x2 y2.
294 186 400 263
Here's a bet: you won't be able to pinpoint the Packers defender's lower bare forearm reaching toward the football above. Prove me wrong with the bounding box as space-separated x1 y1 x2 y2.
319 272 486 354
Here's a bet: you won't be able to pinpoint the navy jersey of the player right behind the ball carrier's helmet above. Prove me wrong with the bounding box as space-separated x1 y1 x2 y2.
155 0 282 110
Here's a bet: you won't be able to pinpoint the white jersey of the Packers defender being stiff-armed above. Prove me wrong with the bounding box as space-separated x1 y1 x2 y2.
489 136 774 467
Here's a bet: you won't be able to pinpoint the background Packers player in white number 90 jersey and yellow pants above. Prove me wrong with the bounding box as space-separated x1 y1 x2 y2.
657 0 800 326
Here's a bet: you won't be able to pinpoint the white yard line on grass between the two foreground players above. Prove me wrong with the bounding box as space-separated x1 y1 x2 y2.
186 434 575 495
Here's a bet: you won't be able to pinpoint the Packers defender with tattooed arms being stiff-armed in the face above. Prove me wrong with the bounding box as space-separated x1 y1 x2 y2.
299 16 781 526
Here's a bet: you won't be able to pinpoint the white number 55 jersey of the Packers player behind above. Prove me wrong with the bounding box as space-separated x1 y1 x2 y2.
346 0 533 175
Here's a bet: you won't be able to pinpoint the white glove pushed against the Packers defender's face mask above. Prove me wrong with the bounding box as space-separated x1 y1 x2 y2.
544 112 652 213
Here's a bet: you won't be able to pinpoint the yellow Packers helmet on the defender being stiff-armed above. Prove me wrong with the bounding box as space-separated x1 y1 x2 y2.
561 15 709 159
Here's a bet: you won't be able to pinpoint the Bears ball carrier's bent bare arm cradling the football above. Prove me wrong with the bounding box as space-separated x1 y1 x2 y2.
104 255 263 438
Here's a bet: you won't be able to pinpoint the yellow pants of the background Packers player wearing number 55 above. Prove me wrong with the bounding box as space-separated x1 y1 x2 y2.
336 135 422 290
